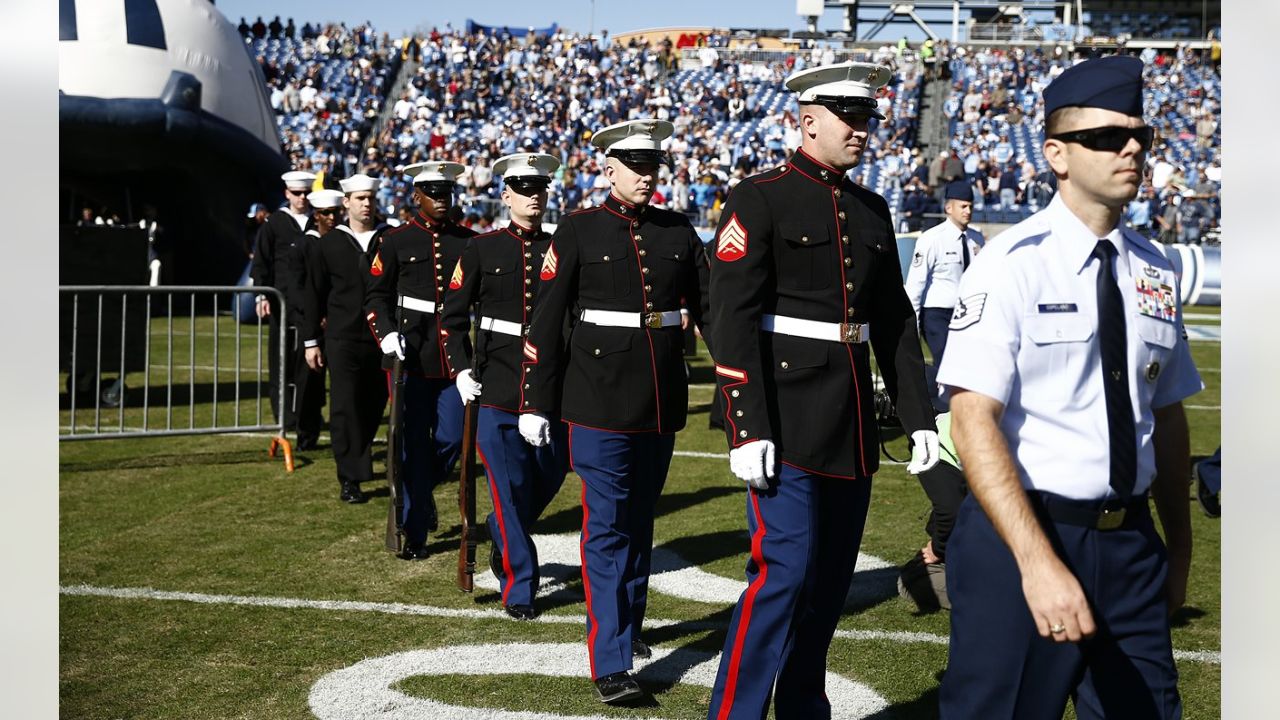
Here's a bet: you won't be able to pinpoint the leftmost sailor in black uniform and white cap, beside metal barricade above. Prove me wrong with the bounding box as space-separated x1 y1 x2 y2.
250 170 324 450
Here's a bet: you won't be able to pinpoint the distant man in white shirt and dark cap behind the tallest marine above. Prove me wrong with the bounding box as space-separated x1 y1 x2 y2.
906 182 984 368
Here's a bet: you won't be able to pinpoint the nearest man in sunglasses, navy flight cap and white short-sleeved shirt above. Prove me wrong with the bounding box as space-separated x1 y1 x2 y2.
938 56 1203 720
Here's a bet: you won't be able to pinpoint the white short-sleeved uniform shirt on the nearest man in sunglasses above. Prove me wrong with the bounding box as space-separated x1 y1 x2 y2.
938 196 1204 500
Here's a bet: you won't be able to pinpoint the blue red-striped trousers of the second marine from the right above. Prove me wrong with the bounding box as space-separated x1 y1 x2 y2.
568 424 676 680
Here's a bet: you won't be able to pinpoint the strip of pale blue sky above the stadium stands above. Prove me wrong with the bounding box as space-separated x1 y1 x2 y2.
216 0 988 41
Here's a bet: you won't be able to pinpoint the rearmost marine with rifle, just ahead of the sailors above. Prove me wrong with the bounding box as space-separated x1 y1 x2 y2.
365 160 475 560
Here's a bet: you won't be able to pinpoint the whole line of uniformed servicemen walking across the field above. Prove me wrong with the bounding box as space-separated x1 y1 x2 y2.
253 56 1202 720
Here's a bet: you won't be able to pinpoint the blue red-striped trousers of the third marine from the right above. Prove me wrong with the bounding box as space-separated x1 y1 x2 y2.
476 406 568 606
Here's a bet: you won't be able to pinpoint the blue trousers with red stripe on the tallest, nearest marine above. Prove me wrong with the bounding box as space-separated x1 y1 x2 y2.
707 465 872 720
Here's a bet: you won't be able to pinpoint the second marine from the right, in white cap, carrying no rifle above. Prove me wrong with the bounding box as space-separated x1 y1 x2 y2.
520 119 708 702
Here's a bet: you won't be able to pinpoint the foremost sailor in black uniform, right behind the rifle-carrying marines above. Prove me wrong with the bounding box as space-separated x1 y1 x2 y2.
302 174 387 503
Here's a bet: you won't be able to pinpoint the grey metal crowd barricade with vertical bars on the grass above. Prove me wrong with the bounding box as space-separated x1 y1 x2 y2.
58 286 296 471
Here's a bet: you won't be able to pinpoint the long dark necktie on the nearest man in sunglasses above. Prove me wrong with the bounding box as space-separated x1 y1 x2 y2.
1093 240 1138 501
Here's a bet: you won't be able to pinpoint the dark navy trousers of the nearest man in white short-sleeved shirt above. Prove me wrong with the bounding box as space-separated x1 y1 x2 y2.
940 496 1183 720
